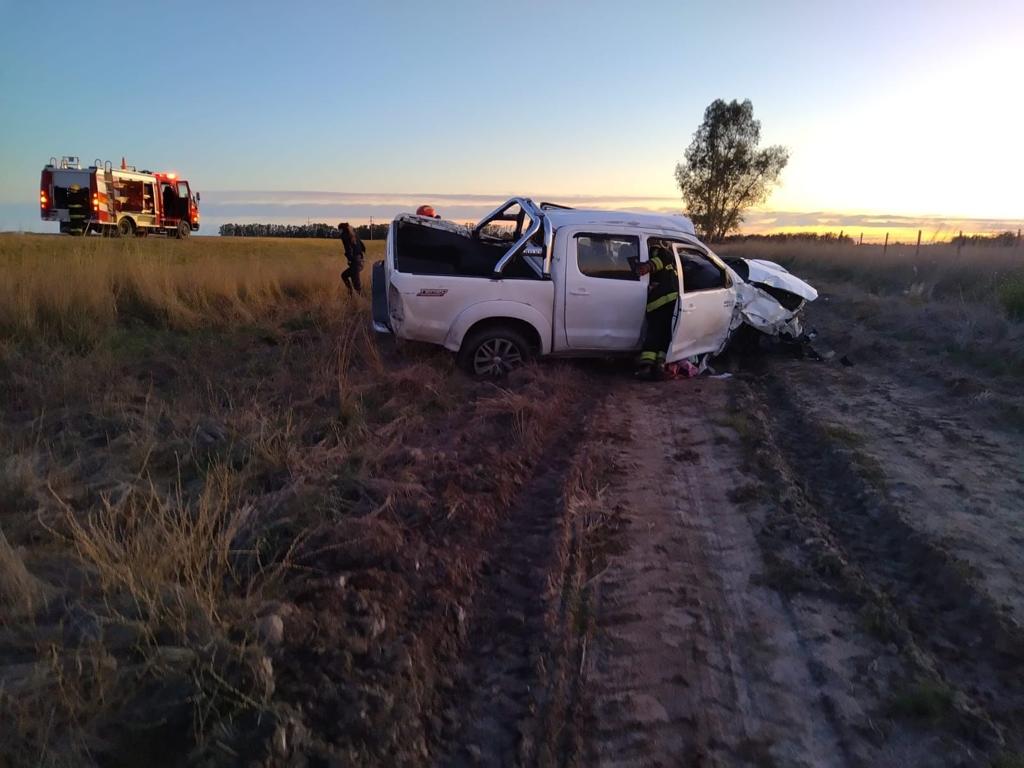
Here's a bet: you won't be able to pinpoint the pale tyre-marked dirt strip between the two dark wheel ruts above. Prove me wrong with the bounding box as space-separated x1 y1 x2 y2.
582 382 851 766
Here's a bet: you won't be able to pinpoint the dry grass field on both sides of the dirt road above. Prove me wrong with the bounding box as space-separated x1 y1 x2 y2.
0 236 1024 766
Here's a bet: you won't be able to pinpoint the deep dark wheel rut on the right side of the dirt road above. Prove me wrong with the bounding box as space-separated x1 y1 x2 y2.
758 374 1024 753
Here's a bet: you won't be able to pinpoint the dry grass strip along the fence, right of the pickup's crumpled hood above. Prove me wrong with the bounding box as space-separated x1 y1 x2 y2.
717 241 1024 318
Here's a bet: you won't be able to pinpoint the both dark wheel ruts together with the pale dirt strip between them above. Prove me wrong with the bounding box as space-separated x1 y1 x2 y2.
434 360 1024 768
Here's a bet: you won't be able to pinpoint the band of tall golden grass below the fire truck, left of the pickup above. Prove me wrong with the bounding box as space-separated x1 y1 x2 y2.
0 234 383 349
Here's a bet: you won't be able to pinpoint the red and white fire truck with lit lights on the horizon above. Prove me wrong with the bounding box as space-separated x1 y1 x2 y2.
39 156 200 239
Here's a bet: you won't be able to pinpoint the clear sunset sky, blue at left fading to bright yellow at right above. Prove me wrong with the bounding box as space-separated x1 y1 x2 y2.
0 0 1024 238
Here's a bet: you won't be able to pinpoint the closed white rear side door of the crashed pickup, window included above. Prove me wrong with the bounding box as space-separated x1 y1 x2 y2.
562 230 647 351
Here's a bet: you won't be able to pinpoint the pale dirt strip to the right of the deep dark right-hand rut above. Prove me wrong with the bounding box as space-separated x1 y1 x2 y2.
773 354 1024 622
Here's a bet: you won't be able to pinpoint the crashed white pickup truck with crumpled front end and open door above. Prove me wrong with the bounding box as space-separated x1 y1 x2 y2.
373 198 817 377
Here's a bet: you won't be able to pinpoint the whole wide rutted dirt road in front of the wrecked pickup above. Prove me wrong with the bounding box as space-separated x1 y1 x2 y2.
437 290 1024 766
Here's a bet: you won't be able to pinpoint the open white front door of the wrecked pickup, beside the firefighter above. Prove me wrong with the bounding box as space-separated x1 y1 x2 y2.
666 244 736 362
